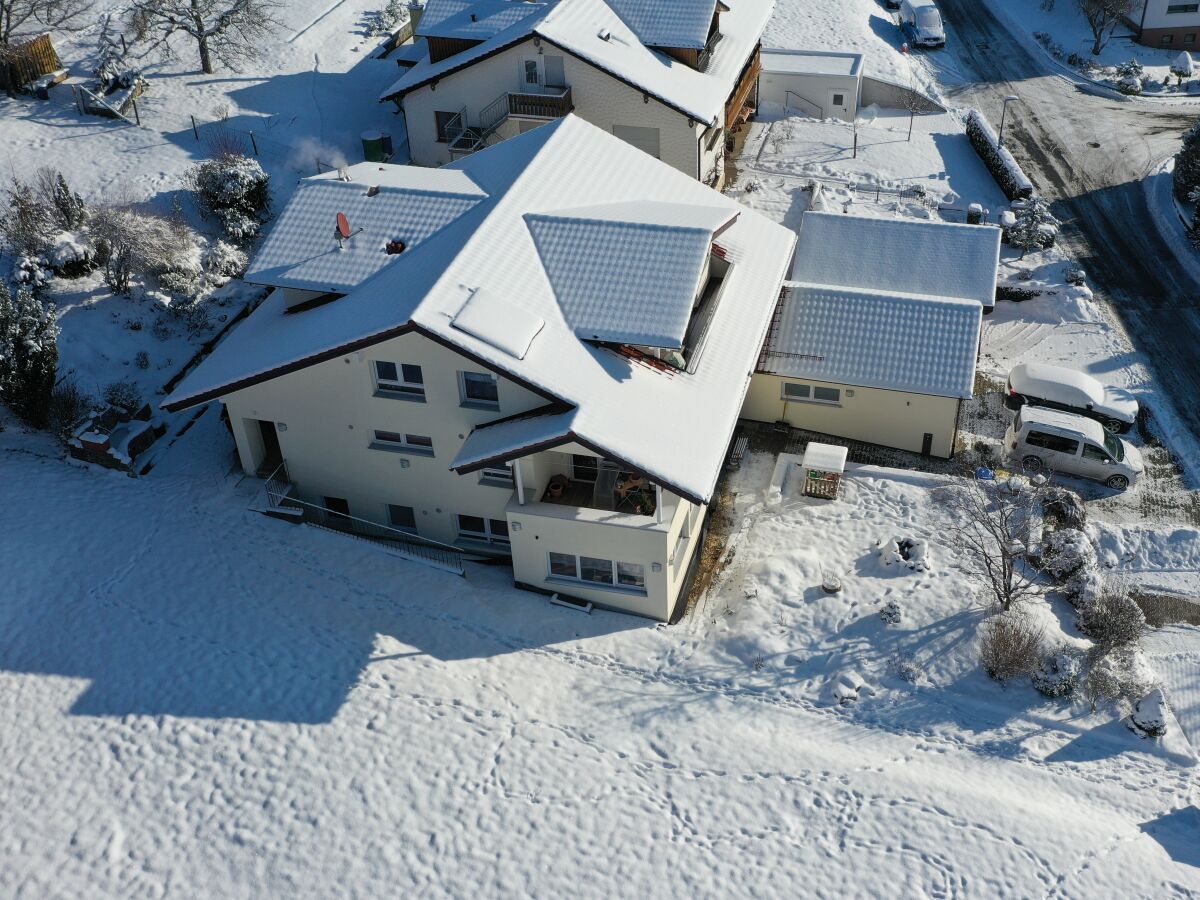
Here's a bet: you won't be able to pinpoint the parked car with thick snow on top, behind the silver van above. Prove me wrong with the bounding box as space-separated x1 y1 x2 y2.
1004 362 1138 434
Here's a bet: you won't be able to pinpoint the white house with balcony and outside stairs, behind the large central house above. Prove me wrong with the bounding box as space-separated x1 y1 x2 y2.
382 0 773 187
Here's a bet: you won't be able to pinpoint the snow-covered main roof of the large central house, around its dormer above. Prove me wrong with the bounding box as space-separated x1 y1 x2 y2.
166 115 796 500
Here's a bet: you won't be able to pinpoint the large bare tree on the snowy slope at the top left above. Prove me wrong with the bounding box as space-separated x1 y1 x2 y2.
130 0 280 74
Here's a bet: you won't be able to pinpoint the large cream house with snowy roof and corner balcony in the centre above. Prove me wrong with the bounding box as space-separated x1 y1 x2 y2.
164 116 796 619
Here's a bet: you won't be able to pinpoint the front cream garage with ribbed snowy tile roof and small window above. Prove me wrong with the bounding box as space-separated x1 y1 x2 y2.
742 282 983 457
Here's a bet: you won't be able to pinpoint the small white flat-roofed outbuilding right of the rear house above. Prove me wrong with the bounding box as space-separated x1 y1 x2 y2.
758 49 863 122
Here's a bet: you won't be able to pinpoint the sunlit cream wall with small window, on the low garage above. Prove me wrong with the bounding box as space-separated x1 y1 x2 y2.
742 372 959 457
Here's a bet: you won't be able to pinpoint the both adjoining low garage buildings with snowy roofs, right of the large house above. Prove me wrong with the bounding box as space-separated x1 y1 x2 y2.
743 212 1000 457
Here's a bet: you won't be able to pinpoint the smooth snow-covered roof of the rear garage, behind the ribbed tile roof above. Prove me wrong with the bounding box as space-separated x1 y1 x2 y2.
792 212 1000 307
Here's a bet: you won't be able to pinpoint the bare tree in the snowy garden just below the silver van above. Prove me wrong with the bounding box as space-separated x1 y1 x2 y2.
938 479 1042 612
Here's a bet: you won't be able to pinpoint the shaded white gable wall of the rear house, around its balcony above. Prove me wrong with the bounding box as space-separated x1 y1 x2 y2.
403 40 706 178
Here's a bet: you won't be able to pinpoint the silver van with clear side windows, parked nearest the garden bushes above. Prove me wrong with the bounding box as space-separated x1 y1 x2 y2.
1004 407 1145 491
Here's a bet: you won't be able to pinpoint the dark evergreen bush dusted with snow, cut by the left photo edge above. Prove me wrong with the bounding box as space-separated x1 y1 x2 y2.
0 282 59 427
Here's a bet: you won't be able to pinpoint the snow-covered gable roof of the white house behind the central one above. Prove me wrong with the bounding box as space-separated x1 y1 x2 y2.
380 0 774 122
